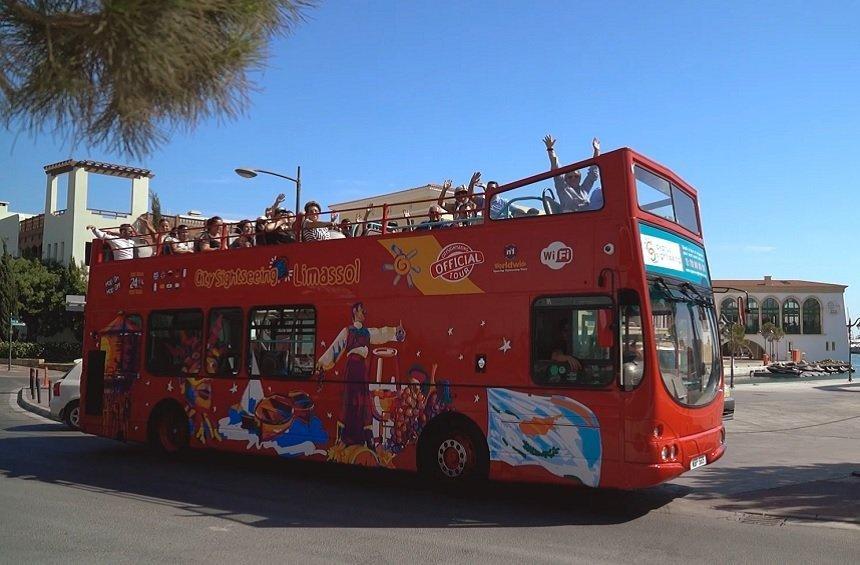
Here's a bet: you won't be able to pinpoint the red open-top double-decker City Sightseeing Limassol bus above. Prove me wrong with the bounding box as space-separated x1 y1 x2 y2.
81 149 725 488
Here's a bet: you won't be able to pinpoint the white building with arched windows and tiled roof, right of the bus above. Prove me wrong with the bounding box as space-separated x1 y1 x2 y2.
712 276 849 361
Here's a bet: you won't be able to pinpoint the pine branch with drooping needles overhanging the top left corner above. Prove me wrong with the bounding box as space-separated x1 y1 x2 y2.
0 0 316 156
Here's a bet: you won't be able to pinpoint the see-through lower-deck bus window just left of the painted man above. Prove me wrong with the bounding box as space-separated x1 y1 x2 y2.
248 306 316 379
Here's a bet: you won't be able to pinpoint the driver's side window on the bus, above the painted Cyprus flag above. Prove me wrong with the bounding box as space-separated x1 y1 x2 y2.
532 296 613 387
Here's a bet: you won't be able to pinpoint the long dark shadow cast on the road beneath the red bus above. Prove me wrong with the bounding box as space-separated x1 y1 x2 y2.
0 426 688 528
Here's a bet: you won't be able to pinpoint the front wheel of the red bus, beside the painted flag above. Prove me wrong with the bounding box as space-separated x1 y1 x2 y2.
419 422 489 482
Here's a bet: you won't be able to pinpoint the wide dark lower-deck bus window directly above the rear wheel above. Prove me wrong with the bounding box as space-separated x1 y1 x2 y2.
146 310 203 377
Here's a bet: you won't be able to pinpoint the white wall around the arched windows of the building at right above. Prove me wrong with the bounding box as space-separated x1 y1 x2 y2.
714 292 850 361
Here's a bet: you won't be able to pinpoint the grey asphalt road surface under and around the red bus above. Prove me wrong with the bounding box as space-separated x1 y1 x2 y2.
0 369 860 563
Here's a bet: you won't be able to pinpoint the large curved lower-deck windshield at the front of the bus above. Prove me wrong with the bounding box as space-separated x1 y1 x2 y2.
649 277 720 406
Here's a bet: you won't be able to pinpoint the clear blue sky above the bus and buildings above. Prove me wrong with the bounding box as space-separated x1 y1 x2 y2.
0 1 860 315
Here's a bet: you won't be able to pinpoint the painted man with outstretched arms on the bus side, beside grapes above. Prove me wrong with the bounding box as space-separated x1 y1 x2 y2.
317 302 406 449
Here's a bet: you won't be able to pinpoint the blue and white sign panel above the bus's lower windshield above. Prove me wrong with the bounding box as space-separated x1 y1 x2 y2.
639 224 711 287
